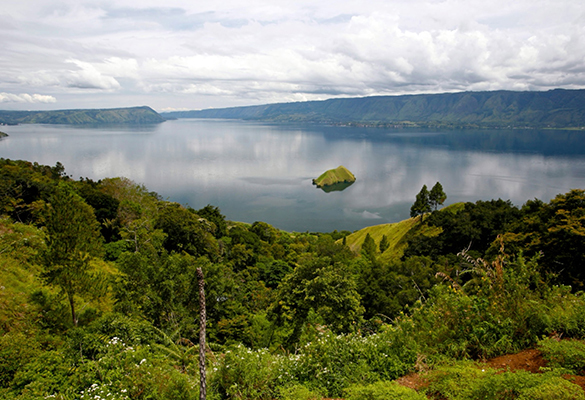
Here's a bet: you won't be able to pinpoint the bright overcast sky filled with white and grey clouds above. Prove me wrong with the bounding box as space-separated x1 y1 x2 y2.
0 0 585 112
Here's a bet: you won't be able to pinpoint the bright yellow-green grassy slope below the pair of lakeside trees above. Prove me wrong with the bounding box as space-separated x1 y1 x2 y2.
346 203 463 262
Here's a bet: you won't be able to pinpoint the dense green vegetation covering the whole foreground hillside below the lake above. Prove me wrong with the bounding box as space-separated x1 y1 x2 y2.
0 159 585 400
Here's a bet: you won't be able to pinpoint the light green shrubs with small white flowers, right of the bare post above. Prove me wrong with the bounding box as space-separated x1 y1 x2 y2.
211 330 416 399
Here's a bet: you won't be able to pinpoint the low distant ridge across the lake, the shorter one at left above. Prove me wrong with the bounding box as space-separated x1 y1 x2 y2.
0 106 165 125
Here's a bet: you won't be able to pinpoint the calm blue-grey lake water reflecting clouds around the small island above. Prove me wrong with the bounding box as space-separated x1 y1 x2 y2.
0 119 585 231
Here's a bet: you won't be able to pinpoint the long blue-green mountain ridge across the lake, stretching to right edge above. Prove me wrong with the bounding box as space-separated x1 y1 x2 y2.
163 89 585 128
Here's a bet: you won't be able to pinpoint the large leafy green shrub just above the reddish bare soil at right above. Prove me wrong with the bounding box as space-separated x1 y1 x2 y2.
396 250 560 358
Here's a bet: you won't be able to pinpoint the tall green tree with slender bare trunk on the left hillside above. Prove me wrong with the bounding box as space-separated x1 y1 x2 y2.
43 184 102 325
